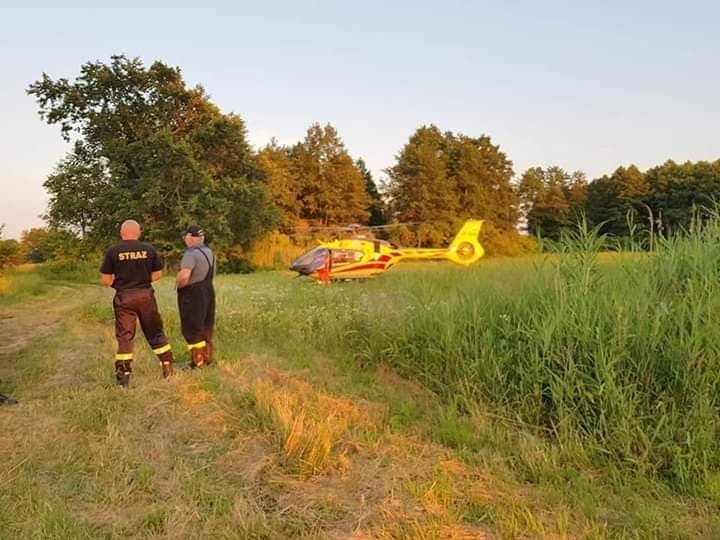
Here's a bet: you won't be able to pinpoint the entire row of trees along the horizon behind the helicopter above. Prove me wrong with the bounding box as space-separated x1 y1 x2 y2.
4 55 720 270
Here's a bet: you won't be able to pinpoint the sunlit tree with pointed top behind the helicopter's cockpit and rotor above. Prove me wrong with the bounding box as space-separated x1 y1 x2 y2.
290 124 371 225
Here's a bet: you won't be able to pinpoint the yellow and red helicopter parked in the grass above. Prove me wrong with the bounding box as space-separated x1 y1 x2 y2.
290 219 485 283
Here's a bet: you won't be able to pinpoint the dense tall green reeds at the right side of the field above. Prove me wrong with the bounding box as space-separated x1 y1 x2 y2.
358 225 720 496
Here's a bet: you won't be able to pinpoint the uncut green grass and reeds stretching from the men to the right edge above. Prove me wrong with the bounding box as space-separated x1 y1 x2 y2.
152 224 720 492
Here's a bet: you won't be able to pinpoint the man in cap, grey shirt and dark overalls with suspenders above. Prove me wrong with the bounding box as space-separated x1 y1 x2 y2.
177 226 215 368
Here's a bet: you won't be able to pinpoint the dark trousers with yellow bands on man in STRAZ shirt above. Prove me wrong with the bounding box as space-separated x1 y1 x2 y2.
113 289 170 360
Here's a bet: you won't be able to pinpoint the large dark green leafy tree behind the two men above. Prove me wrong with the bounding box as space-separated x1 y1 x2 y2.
28 55 274 258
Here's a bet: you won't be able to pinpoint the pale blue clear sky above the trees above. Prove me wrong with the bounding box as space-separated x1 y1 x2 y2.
0 0 720 238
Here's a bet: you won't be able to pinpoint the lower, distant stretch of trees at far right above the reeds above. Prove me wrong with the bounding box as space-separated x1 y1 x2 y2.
518 160 720 241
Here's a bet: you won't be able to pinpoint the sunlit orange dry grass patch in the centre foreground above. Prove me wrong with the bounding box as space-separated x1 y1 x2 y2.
214 358 504 540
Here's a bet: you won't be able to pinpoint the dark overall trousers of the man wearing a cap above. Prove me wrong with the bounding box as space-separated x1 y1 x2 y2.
178 280 215 349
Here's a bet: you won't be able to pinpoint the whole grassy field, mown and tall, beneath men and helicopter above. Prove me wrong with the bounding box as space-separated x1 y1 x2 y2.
0 232 720 539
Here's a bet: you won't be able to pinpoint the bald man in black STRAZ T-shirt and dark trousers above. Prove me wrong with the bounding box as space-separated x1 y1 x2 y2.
100 219 173 386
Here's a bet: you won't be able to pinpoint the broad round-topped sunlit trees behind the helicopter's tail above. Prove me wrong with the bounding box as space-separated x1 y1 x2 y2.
387 125 517 245
